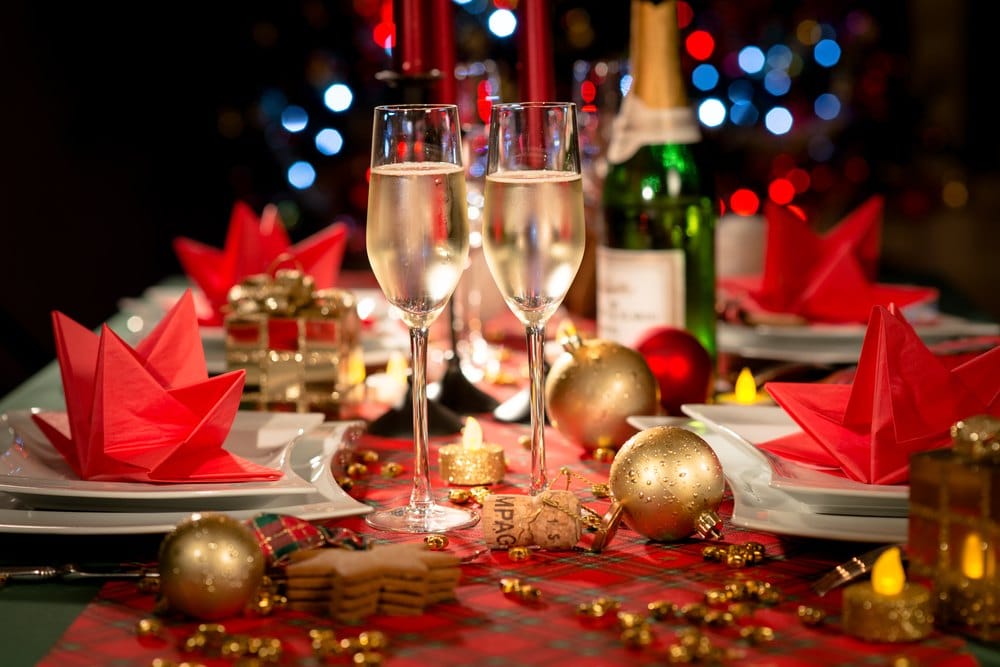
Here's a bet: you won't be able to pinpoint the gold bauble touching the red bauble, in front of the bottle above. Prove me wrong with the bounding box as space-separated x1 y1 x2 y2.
545 337 660 450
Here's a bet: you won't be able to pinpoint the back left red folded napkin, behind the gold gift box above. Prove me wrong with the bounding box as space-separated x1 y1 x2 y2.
174 202 348 325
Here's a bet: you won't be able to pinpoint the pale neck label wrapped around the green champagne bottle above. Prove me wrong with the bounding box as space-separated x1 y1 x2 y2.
608 95 701 164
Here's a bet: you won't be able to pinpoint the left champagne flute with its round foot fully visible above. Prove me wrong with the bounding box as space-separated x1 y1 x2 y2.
366 104 479 533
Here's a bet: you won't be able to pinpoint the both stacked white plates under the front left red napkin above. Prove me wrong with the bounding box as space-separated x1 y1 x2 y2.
0 410 371 535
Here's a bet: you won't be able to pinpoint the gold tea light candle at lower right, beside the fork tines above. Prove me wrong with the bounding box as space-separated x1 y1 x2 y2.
843 547 934 642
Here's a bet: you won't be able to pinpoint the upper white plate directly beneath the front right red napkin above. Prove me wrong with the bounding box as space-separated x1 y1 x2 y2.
681 404 910 516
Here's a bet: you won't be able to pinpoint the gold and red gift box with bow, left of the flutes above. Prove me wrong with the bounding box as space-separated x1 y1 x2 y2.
224 269 365 419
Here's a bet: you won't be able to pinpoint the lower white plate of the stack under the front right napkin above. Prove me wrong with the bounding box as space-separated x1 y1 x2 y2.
628 416 908 543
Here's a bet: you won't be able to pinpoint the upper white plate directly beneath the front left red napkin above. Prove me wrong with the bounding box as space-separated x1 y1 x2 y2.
0 410 324 511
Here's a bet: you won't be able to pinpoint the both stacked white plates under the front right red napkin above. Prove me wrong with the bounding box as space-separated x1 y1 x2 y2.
629 404 909 542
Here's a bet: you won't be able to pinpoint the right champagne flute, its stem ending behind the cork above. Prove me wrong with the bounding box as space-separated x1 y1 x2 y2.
483 102 585 495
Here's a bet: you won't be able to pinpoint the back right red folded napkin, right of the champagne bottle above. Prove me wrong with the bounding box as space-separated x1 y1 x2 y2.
719 195 937 323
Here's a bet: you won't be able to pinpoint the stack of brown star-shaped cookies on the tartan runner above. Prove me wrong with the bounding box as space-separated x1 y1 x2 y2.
285 542 461 621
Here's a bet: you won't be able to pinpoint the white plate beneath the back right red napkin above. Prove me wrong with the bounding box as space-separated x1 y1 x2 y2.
717 315 1000 364
